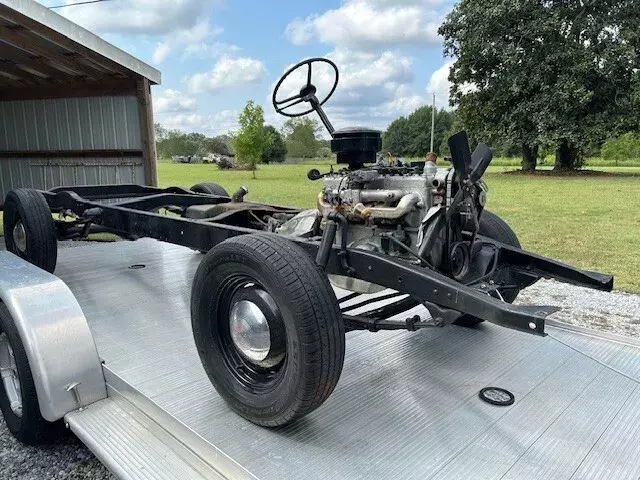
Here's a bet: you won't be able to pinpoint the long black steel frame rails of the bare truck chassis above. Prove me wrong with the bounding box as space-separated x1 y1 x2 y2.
42 185 613 335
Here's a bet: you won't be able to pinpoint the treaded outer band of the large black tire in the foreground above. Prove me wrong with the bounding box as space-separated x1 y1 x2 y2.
192 233 345 427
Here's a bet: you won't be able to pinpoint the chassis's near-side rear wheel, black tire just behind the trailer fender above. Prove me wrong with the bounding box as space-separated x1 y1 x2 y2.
4 188 58 273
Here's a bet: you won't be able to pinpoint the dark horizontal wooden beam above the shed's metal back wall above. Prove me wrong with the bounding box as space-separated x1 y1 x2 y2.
0 79 137 101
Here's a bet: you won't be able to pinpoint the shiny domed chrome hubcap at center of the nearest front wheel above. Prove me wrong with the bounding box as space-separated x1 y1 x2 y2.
229 300 271 363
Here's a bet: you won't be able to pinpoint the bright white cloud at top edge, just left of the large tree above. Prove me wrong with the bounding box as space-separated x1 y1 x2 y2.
285 0 444 49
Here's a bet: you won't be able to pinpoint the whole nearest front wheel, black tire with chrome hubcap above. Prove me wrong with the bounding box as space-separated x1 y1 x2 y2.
191 234 345 427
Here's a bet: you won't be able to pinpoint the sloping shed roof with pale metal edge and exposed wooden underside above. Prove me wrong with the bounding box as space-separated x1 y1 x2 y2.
0 0 161 88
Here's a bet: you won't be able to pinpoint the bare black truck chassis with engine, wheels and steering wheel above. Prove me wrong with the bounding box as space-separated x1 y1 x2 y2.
0 59 613 427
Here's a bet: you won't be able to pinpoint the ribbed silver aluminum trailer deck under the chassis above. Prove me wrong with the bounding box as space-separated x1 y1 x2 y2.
42 239 640 480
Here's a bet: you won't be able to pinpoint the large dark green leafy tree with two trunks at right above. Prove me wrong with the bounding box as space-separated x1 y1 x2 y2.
439 0 640 170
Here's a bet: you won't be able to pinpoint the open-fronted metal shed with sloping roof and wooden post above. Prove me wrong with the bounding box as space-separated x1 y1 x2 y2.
0 0 160 202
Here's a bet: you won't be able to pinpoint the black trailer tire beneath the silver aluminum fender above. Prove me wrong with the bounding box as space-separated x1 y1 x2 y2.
0 303 67 445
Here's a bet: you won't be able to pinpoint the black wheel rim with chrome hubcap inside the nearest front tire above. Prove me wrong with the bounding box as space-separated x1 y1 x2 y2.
213 275 286 393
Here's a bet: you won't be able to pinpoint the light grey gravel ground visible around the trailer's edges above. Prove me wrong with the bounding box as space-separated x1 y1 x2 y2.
0 238 640 480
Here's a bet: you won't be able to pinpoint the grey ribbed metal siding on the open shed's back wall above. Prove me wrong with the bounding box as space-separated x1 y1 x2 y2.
0 96 148 197
